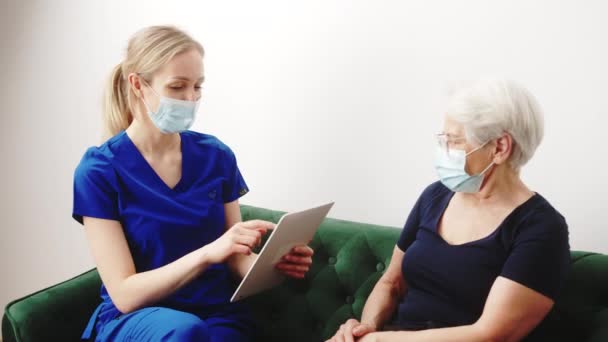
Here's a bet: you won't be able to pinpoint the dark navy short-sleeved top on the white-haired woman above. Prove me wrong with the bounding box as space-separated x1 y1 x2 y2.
396 182 570 328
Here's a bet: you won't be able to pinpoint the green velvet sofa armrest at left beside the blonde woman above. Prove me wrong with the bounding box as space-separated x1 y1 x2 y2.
2 269 101 342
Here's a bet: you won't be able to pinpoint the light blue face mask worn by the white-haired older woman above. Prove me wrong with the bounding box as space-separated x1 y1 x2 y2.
435 142 494 193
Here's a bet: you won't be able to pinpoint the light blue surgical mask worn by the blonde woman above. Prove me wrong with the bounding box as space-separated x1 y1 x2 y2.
142 81 200 134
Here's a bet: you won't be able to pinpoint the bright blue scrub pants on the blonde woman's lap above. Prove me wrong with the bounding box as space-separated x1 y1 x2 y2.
89 307 254 342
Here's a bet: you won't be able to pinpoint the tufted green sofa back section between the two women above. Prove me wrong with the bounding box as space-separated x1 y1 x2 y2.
241 206 400 342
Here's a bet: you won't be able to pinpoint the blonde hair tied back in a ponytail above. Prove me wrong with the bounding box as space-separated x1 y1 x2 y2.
103 26 205 138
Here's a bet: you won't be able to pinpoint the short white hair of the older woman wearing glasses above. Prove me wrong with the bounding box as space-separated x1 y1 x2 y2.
446 79 544 170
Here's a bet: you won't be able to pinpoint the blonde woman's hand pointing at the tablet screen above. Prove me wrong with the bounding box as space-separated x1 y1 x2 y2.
202 220 274 264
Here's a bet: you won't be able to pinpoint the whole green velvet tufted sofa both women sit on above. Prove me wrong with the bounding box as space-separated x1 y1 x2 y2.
2 205 608 342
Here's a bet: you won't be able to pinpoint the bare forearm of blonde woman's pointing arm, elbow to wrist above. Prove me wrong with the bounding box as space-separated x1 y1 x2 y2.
108 249 210 313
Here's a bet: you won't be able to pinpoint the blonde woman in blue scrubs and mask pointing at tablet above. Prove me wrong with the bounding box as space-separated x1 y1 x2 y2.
73 26 313 341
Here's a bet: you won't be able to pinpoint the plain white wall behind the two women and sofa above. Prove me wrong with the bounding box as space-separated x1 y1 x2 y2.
0 0 608 314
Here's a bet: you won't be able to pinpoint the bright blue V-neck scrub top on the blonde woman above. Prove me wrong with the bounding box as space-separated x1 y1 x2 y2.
72 131 248 340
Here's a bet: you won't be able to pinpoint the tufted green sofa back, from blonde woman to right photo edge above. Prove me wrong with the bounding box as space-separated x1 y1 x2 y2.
242 206 608 342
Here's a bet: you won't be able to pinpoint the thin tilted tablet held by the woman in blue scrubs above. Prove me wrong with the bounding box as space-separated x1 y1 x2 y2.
230 202 334 302
